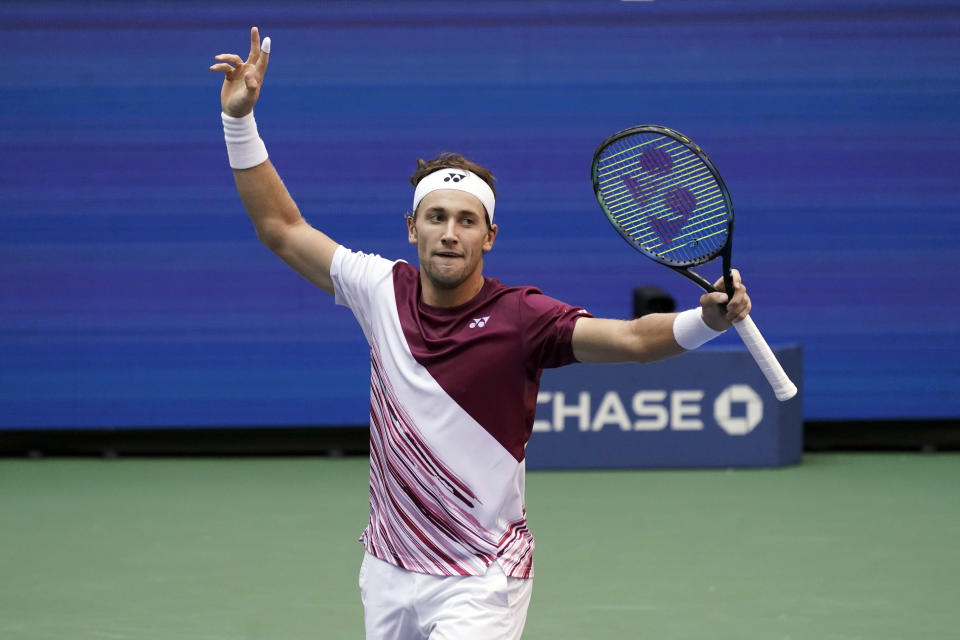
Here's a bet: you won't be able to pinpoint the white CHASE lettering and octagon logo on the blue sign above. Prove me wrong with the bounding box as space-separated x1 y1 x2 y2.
533 384 763 436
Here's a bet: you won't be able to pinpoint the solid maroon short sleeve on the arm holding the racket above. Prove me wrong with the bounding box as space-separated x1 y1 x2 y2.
519 289 593 369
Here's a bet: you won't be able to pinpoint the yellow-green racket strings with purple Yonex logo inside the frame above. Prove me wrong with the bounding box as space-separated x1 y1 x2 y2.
595 134 730 263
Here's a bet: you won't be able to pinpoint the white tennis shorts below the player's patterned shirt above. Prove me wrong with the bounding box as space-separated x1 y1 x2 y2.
360 553 533 640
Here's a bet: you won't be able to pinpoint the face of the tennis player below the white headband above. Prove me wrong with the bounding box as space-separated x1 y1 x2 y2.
407 189 497 291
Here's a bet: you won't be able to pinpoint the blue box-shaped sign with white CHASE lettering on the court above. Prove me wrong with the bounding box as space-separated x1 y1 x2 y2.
527 346 803 469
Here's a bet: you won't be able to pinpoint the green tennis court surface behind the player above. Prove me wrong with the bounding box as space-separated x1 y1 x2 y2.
0 454 960 640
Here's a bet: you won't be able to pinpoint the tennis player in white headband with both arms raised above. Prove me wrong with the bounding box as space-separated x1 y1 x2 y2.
210 27 750 640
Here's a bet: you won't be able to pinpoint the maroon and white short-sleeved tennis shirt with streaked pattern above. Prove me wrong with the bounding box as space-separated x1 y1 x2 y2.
330 246 589 578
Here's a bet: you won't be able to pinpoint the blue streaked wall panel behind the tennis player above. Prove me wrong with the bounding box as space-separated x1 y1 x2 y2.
0 0 960 429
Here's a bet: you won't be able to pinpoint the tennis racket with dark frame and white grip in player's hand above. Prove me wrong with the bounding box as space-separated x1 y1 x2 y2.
591 125 797 400
